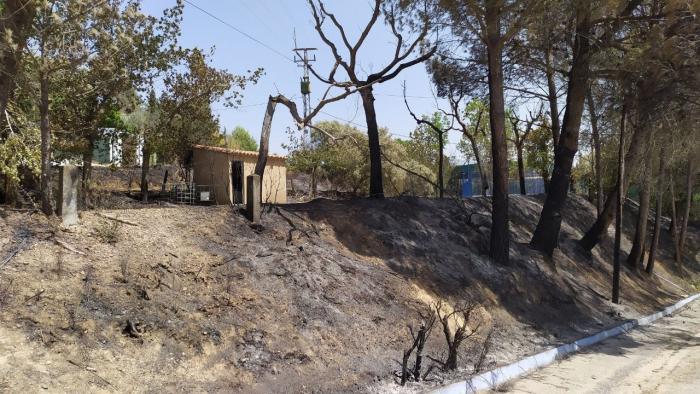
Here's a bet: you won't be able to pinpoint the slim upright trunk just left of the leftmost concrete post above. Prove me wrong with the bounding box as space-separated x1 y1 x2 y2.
39 70 53 215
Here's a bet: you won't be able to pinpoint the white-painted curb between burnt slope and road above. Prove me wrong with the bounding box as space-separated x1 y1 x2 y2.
431 293 700 394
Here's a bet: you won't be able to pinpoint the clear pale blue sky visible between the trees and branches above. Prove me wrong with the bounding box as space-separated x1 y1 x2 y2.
143 0 462 161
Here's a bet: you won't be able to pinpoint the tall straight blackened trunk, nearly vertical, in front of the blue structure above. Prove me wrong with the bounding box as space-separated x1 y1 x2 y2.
485 2 510 264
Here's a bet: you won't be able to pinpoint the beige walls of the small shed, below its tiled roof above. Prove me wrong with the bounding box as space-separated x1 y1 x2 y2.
192 149 287 204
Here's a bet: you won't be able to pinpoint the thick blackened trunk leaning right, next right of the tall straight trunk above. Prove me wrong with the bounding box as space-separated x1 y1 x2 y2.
530 2 591 256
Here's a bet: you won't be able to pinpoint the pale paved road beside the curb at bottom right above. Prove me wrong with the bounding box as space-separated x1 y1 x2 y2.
508 300 700 394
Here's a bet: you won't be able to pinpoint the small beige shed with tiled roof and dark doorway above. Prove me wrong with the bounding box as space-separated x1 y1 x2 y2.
191 145 287 204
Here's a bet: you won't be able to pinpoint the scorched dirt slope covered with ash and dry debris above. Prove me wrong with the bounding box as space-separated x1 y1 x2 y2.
0 196 700 393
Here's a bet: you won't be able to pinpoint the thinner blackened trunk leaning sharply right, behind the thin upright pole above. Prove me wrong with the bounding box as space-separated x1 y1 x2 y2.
579 118 652 250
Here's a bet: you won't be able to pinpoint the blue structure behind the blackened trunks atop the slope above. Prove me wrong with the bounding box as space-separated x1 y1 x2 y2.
451 164 544 197
